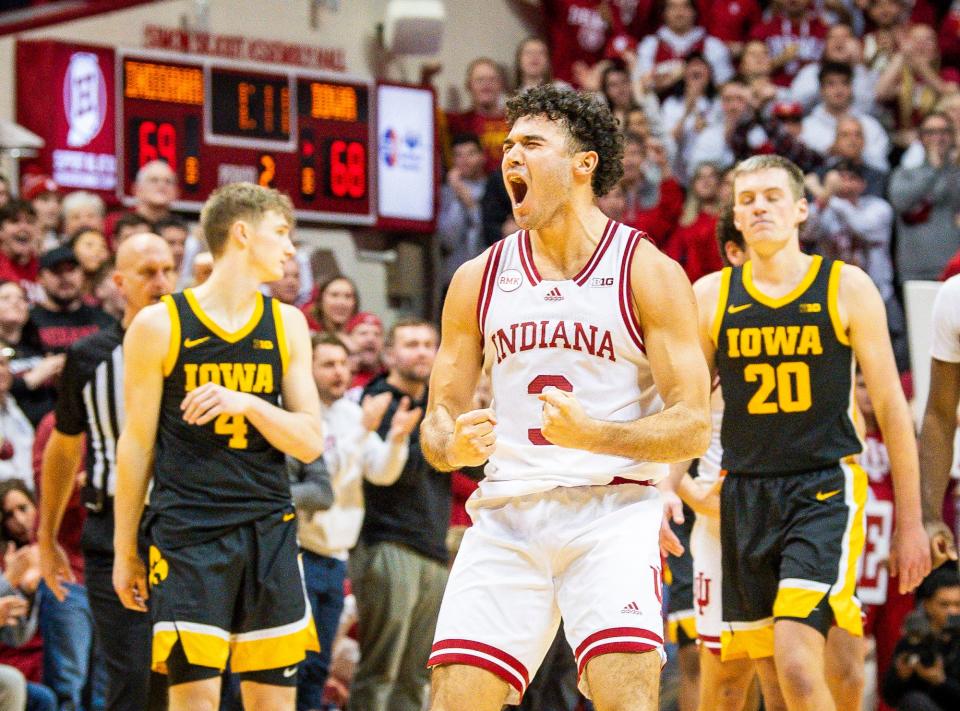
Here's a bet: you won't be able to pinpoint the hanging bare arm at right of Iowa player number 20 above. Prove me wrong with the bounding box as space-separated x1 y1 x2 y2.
839 264 930 593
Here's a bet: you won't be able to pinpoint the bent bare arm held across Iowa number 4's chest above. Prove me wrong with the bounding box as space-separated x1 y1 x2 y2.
181 304 323 462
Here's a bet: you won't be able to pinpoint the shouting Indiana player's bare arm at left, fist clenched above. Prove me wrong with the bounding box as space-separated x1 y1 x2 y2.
420 252 497 471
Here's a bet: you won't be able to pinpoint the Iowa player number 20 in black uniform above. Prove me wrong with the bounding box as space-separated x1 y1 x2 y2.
695 156 930 711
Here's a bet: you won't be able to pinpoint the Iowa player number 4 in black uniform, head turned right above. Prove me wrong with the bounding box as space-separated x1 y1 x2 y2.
114 183 323 711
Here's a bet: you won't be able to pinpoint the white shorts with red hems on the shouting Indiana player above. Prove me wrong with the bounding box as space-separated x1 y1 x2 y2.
428 483 665 704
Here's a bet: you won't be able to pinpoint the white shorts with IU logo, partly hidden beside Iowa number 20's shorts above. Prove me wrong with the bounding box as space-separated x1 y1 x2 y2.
690 516 723 654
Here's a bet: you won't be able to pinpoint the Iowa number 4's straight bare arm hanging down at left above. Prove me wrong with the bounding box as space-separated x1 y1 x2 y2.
113 304 170 612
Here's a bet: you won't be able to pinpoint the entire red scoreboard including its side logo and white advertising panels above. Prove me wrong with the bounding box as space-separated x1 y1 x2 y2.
15 40 439 232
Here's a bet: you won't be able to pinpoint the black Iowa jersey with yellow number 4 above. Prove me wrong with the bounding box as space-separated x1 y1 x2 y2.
150 289 290 548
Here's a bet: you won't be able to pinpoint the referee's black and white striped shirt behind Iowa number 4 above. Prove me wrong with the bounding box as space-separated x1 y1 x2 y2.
56 323 124 511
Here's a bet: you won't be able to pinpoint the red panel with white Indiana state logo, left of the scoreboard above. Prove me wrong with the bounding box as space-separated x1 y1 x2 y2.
16 41 117 201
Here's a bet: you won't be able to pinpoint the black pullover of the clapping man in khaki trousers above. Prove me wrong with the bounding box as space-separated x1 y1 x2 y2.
360 375 451 564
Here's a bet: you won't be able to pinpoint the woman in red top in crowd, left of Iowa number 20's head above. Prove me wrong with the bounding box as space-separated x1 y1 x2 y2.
665 163 723 284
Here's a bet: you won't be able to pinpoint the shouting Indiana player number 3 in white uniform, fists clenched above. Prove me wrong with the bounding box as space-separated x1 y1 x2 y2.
421 87 710 711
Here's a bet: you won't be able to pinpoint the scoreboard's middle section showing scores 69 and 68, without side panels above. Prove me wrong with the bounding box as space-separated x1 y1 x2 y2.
116 50 376 224
